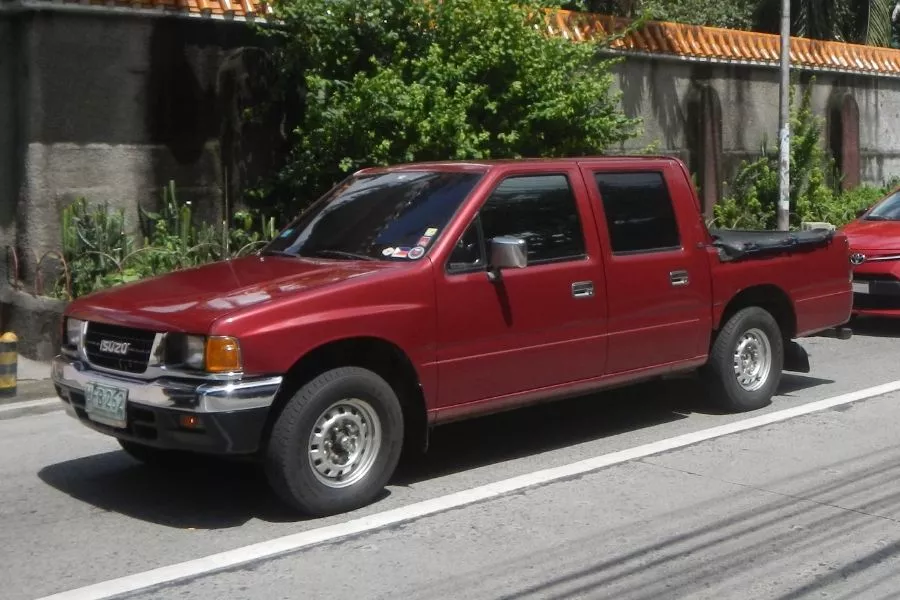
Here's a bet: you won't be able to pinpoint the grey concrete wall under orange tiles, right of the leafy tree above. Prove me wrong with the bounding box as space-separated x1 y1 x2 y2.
617 58 900 190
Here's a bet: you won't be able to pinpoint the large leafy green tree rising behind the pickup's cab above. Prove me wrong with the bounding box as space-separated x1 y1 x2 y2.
260 0 639 216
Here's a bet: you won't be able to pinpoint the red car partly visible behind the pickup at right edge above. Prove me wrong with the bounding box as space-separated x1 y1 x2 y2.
843 189 900 317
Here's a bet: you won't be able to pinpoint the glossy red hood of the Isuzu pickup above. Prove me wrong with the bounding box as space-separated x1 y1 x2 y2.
67 256 398 333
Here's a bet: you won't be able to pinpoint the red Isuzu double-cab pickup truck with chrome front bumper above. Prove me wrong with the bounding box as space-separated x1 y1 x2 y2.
53 157 853 515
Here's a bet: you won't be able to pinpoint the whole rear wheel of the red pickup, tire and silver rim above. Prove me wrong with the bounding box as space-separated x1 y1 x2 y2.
702 306 784 412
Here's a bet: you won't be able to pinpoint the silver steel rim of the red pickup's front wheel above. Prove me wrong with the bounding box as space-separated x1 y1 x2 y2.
308 398 381 488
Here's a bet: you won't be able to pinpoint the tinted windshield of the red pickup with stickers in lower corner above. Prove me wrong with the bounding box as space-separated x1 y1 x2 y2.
263 171 483 261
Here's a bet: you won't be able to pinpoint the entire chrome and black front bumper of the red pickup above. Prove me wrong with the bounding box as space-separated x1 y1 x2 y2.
52 356 282 455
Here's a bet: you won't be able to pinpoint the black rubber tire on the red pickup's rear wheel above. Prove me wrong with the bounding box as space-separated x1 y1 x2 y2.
701 306 784 413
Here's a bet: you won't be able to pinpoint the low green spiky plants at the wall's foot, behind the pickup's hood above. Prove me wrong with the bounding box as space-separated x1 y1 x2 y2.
55 182 276 298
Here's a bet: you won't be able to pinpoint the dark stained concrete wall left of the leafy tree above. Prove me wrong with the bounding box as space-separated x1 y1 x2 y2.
0 11 268 280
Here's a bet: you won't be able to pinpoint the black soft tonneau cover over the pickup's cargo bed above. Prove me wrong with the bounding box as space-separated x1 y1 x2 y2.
710 229 835 262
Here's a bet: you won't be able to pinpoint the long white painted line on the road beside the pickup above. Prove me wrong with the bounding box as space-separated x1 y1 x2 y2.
39 380 900 600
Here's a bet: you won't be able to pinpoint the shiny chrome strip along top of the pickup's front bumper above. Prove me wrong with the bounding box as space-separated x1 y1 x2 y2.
52 356 282 413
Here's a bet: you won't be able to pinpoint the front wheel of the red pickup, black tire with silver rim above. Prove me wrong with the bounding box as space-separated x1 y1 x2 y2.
264 367 404 516
